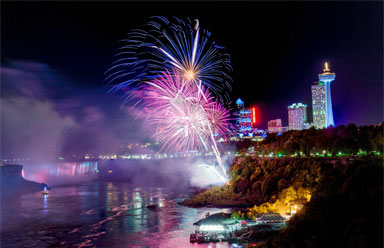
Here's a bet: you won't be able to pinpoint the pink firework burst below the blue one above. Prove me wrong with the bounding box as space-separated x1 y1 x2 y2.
143 69 229 151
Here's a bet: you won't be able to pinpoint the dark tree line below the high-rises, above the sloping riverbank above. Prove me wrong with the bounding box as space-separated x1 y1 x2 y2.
232 122 384 156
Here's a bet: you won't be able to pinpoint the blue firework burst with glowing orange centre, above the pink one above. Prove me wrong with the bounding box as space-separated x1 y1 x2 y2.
106 17 232 101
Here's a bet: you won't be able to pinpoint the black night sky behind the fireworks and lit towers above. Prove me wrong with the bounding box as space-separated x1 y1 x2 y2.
1 2 383 157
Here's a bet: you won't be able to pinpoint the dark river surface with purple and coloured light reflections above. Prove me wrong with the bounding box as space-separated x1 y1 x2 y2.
1 182 230 248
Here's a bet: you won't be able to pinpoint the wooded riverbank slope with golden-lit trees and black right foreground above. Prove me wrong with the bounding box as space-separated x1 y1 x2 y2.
182 156 384 247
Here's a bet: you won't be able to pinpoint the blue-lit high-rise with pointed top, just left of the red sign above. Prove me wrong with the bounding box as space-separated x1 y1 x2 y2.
236 98 253 138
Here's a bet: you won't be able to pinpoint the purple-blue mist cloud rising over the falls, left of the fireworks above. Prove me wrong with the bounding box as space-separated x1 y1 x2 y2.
1 60 143 160
